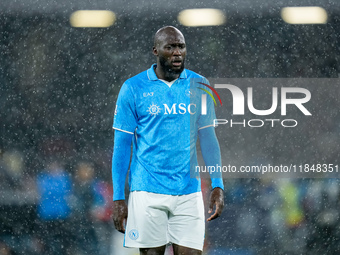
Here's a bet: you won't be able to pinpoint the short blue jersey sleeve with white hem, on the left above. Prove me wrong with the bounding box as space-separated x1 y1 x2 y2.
113 83 137 134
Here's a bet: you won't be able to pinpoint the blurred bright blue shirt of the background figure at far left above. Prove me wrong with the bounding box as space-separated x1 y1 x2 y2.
37 172 72 220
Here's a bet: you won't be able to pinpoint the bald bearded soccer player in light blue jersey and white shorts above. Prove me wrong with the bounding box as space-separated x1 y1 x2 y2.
112 26 224 255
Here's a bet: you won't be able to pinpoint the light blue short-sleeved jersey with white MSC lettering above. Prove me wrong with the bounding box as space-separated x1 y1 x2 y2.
113 65 216 195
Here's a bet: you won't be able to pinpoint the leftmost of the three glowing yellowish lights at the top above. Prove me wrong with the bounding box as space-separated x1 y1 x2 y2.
70 10 116 27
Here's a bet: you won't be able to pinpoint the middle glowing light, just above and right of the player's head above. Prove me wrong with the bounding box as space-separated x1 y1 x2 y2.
178 9 226 27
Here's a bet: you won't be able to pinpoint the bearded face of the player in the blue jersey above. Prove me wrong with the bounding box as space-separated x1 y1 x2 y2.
154 31 186 74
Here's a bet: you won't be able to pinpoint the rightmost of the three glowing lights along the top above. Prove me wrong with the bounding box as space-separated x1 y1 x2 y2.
281 6 328 24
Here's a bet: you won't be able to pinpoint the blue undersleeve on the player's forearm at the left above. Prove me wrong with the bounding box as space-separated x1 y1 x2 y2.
112 130 133 201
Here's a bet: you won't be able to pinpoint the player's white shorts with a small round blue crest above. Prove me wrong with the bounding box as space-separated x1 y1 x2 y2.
124 191 205 251
